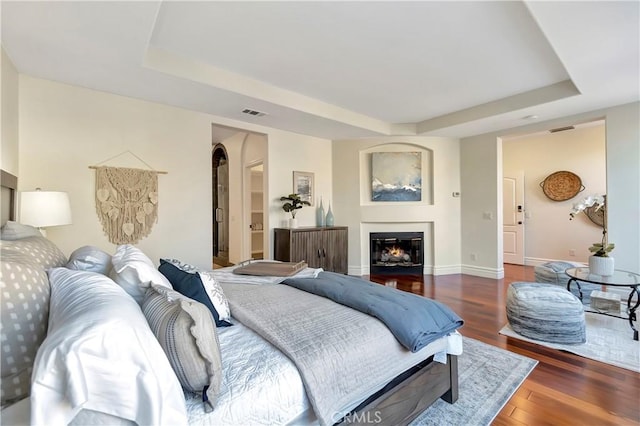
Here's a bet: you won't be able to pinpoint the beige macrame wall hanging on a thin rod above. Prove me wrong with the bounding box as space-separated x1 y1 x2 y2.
90 151 166 244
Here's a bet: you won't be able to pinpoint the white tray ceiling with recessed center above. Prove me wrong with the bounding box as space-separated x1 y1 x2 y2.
1 0 640 139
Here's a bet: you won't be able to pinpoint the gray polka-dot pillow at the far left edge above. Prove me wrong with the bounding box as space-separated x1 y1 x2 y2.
0 245 50 406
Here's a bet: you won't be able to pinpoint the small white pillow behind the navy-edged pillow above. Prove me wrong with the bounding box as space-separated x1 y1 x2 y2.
109 244 173 305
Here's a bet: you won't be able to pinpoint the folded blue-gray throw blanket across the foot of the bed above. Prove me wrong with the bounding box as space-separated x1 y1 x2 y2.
283 272 463 352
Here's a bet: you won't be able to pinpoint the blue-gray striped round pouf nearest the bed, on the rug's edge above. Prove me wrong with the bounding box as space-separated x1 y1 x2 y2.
507 282 587 343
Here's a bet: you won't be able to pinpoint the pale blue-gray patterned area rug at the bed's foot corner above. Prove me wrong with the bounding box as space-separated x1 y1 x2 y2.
411 337 538 426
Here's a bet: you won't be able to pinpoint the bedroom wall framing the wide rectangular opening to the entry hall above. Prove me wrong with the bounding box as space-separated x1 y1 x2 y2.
461 102 640 278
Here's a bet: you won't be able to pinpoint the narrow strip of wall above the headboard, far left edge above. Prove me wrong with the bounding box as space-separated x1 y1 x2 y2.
0 49 19 176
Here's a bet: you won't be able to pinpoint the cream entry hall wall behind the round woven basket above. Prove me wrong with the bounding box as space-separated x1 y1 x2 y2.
502 123 607 265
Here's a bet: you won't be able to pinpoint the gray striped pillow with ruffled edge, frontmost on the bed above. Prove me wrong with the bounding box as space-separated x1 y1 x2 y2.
142 285 222 411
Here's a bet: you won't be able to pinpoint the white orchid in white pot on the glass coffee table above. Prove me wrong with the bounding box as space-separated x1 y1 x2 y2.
569 195 615 276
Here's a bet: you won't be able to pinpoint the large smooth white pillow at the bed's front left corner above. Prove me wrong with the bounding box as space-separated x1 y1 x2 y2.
31 268 187 425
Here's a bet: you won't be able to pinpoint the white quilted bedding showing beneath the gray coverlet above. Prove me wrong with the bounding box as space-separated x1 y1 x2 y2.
1 262 462 426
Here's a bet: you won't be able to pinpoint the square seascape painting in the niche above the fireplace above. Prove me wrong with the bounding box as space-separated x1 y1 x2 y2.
371 152 422 201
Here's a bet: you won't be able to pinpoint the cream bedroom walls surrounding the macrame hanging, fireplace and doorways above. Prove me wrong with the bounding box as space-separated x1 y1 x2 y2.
7 71 640 277
